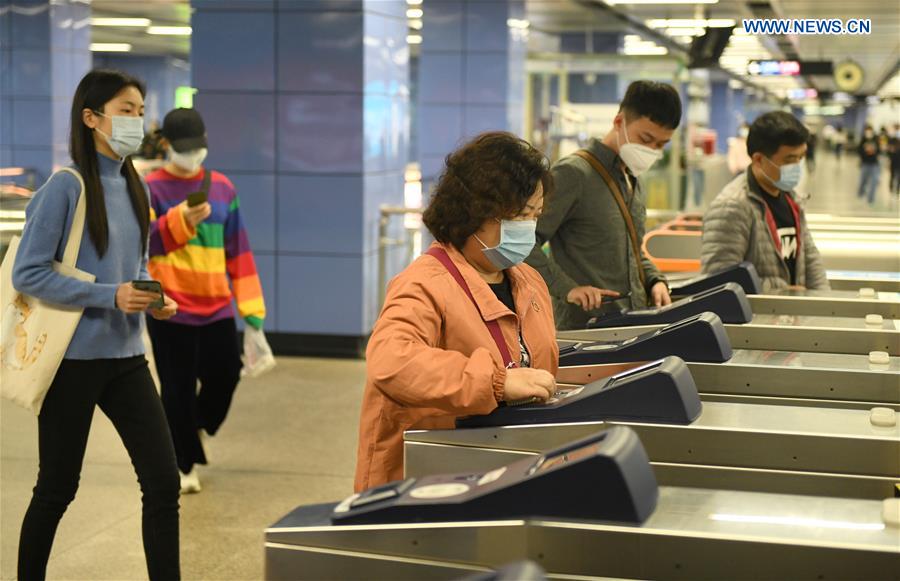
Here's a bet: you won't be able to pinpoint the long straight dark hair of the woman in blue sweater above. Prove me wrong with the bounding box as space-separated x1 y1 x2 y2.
69 69 150 258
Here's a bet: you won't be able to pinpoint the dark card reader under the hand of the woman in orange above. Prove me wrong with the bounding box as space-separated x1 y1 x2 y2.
456 356 702 428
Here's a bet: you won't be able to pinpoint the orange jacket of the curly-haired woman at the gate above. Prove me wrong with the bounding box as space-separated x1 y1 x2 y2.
354 240 559 491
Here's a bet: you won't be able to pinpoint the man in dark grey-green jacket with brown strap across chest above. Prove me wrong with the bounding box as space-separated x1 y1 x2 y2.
526 81 681 330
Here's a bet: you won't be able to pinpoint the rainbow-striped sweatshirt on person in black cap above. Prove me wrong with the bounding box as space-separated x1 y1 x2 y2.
146 169 266 329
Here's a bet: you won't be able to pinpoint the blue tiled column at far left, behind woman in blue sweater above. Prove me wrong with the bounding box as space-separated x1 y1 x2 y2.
0 0 91 181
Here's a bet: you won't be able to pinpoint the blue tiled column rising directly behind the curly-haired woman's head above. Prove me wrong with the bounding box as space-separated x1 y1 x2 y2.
418 0 527 184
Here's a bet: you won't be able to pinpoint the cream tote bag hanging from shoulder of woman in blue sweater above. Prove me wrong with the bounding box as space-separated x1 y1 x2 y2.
0 168 96 414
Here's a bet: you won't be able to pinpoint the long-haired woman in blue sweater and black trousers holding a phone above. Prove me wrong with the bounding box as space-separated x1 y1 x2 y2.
13 70 180 581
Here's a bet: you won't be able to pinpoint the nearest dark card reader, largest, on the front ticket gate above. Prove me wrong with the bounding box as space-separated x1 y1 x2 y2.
331 427 659 525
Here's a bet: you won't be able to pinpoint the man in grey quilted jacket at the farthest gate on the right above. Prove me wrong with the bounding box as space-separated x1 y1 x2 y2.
700 111 829 291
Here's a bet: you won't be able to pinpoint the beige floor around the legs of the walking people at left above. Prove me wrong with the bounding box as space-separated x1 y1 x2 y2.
0 358 365 580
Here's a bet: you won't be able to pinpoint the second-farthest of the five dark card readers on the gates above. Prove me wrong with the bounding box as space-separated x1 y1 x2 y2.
588 282 753 329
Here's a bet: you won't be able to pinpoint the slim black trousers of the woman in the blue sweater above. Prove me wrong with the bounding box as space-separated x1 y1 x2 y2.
19 355 180 581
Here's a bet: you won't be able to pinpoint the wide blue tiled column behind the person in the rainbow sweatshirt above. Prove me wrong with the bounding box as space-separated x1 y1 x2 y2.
191 0 409 351
